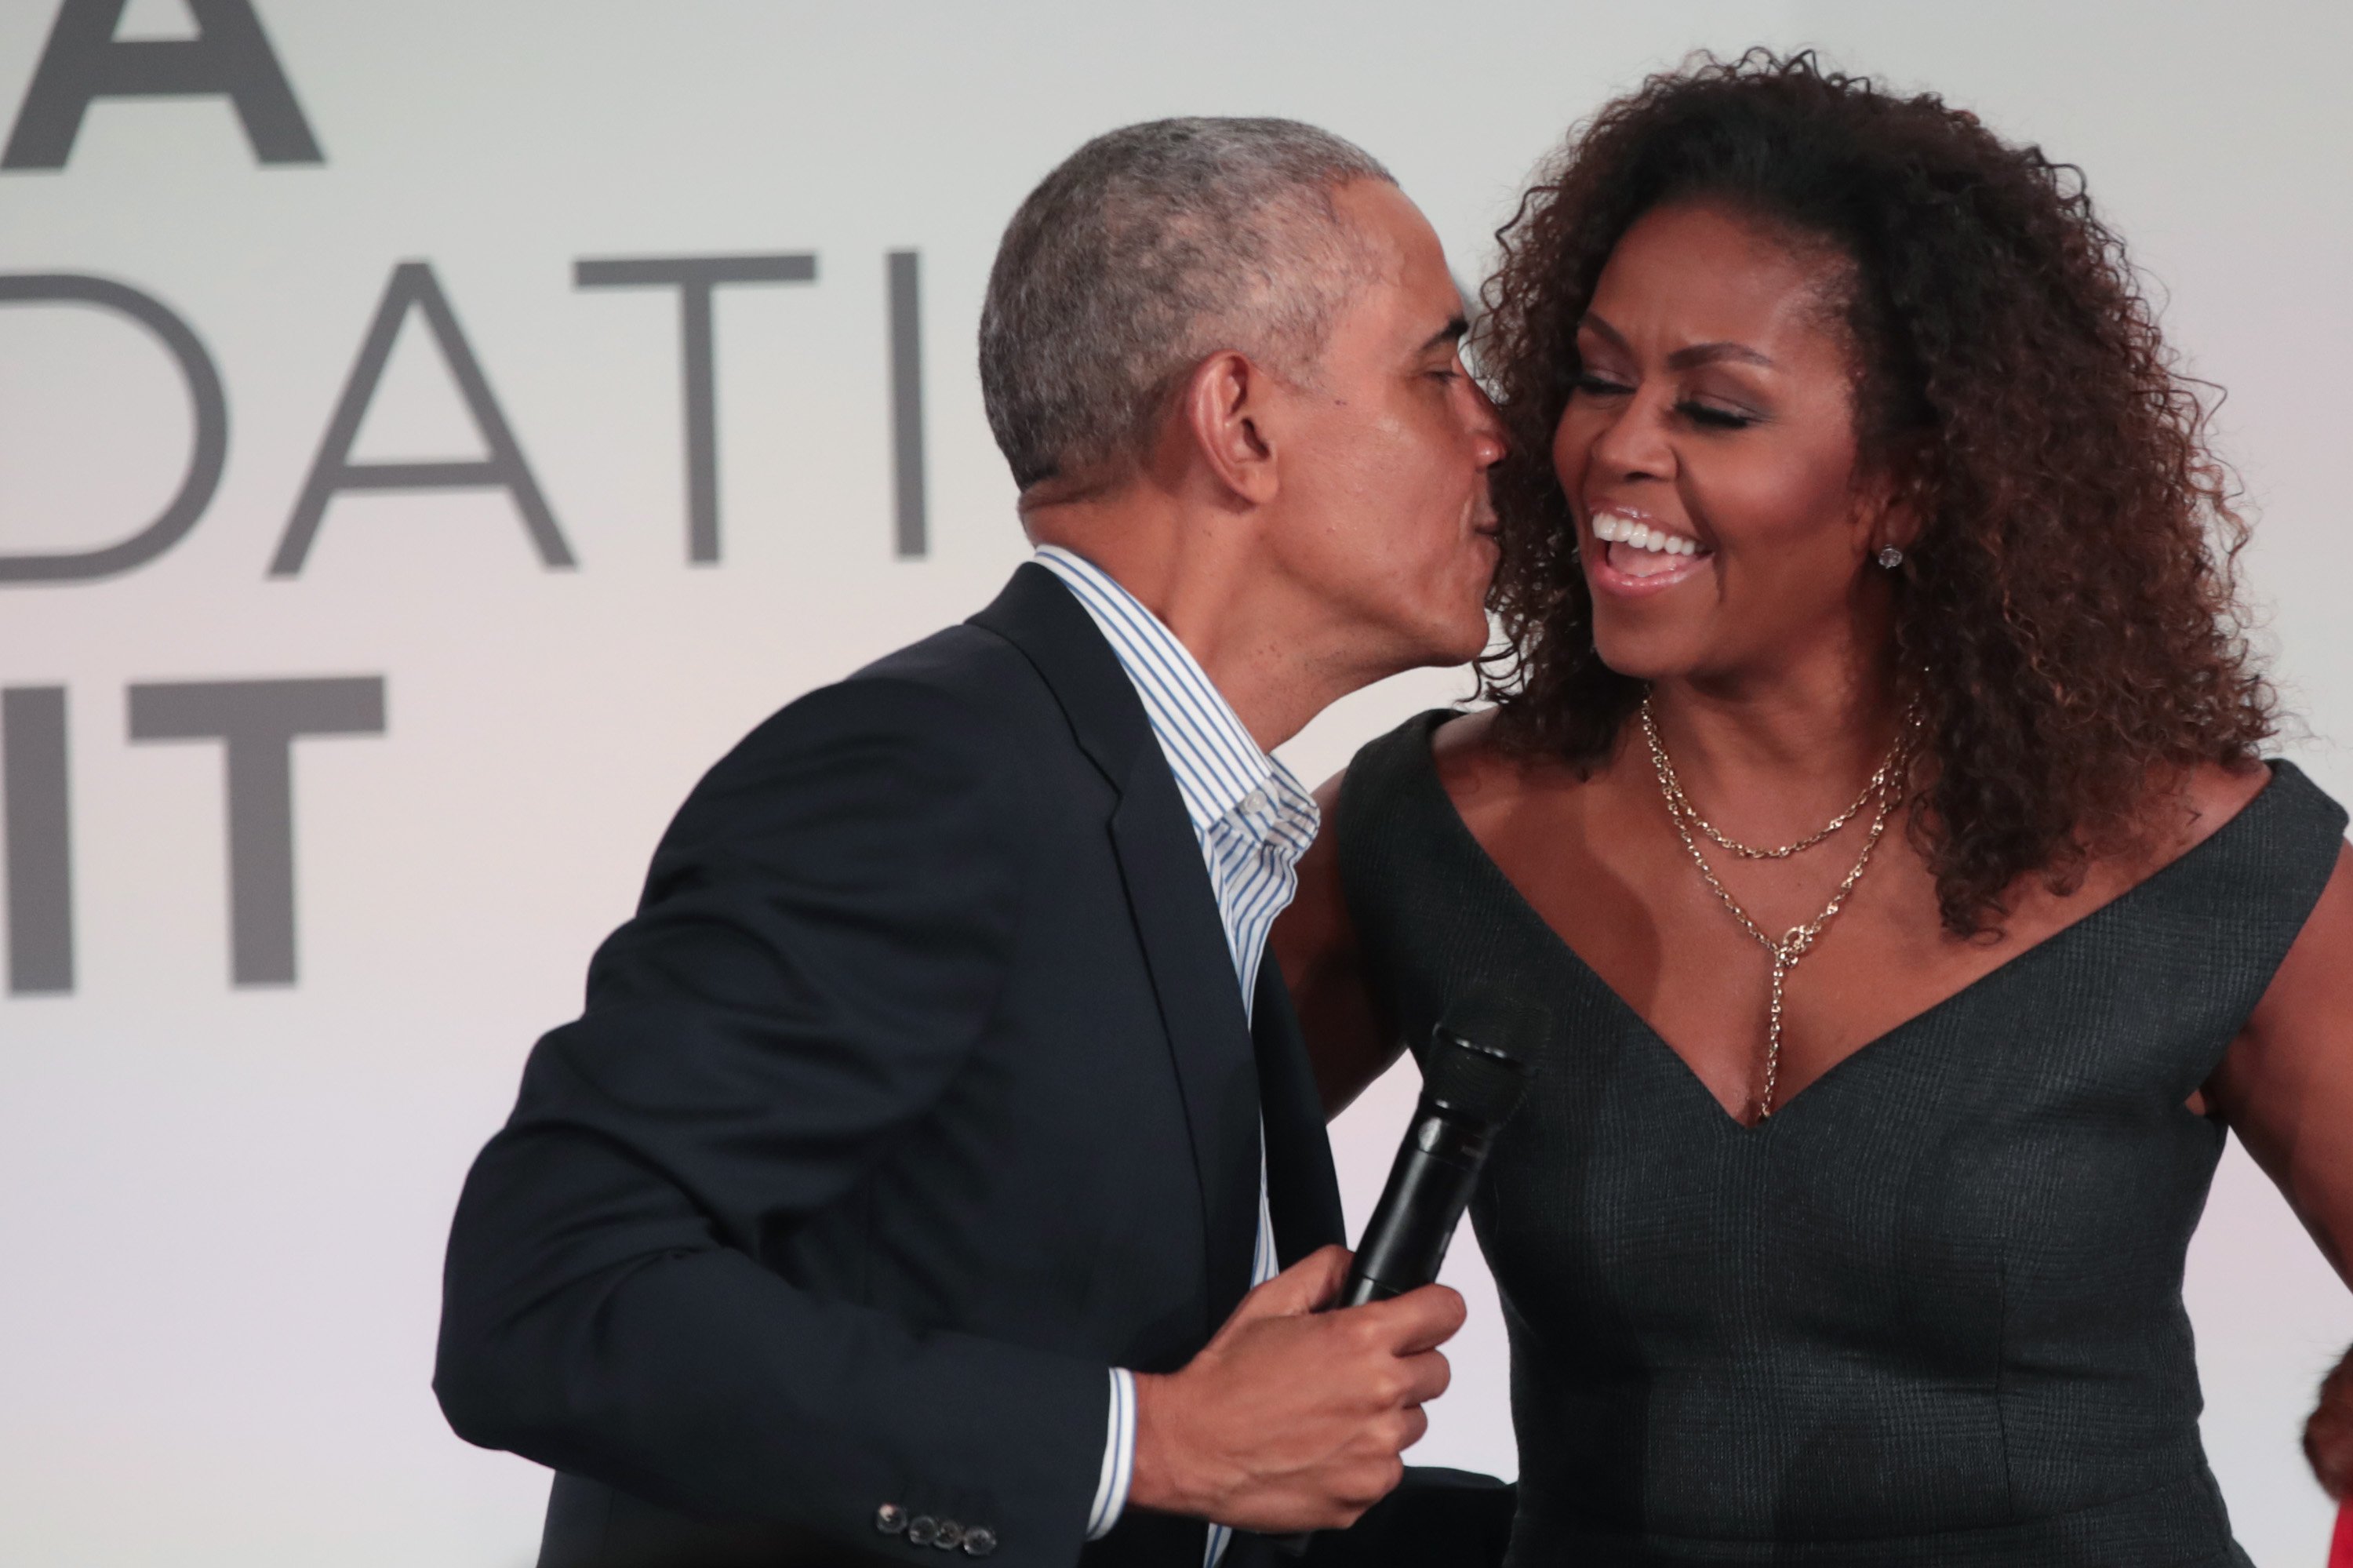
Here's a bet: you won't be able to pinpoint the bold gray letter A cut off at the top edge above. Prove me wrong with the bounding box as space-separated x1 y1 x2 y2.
0 0 327 169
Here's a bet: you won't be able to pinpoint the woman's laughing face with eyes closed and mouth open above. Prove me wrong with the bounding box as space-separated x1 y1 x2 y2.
1553 205 1908 680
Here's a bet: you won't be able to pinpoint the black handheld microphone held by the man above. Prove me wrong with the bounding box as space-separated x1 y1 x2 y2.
1332 1003 1546 1307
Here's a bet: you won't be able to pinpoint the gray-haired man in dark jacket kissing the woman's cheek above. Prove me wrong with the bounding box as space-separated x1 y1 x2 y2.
435 120 1501 1568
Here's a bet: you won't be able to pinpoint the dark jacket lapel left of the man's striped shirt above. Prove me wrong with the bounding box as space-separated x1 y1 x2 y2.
972 565 1271 1337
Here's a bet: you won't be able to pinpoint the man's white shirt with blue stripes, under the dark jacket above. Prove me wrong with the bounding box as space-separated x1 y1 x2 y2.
1035 544 1318 1566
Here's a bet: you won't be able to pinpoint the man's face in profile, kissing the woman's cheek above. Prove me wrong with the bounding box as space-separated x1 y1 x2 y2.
1268 179 1504 673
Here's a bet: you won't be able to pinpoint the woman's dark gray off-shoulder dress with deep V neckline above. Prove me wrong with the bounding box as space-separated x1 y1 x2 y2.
1334 713 2346 1568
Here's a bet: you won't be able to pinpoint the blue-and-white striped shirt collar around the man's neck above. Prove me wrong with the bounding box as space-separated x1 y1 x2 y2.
1035 544 1320 857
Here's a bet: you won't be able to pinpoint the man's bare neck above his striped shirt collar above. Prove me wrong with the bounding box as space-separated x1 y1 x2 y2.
1021 485 1365 751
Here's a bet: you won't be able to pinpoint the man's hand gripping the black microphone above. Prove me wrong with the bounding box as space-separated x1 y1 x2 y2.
1127 1246 1464 1533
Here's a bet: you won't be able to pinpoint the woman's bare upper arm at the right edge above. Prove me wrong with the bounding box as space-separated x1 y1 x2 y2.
2207 846 2353 1283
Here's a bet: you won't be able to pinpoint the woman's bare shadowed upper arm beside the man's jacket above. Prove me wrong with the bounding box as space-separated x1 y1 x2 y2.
1271 772 1400 1116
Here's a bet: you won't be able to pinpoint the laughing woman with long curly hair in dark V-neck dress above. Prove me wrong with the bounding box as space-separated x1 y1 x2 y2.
1278 54 2353 1568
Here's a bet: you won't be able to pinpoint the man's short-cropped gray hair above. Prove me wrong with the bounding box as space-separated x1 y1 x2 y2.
981 118 1395 489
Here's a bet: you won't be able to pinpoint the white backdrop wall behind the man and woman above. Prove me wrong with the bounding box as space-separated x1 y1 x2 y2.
0 0 2353 1568
